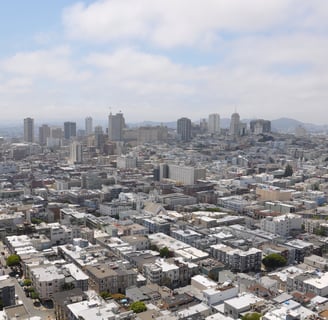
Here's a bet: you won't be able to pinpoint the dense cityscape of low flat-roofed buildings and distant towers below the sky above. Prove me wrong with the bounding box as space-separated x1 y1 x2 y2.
0 112 328 320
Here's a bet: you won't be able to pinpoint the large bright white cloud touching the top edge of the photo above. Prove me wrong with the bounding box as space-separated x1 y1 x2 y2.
63 0 295 48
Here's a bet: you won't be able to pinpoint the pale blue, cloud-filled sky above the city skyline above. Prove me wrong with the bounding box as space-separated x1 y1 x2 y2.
0 0 328 124
